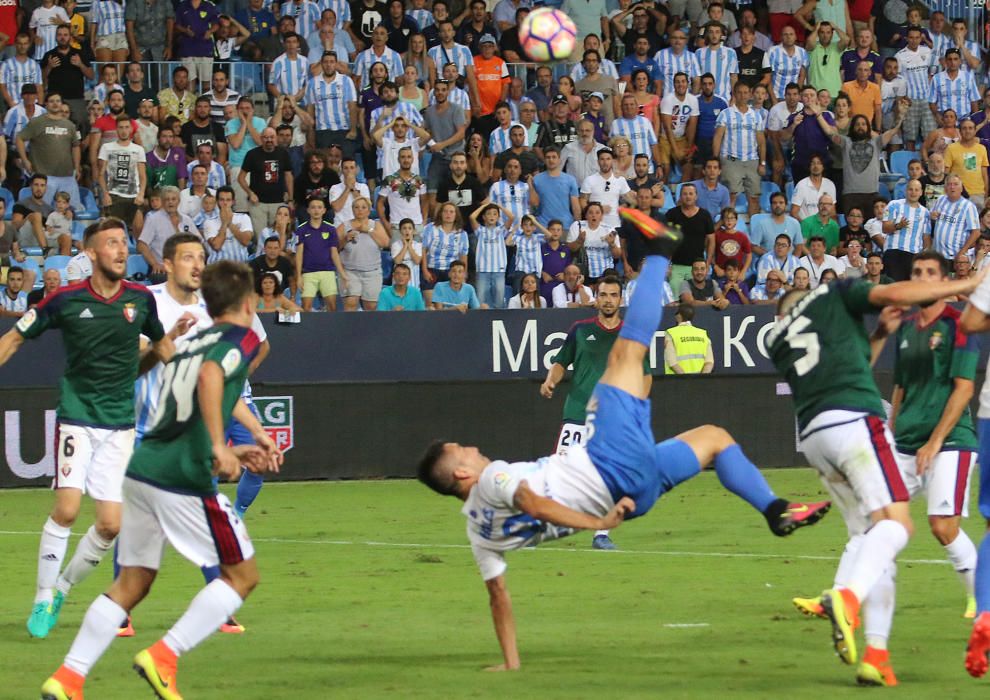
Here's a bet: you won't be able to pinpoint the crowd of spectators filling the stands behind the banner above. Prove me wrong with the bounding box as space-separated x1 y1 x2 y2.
0 0 990 315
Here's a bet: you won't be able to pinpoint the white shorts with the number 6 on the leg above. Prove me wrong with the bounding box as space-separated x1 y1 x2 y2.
52 423 134 503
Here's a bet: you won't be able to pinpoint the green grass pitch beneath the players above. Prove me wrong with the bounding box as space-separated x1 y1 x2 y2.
0 469 988 700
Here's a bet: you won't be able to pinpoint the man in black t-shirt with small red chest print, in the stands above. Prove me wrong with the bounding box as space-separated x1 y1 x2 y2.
239 124 294 235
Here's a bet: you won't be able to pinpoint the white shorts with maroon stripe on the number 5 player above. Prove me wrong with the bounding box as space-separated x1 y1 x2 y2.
801 411 911 534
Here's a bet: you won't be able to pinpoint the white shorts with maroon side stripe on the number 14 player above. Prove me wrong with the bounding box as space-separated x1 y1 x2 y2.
117 479 254 571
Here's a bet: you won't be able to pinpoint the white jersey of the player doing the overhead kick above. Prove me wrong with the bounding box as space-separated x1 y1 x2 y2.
461 446 615 581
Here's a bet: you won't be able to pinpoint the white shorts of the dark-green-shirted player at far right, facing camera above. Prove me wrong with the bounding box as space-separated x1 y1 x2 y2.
897 450 976 518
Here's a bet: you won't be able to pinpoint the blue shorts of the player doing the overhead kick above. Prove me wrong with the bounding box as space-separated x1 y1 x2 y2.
586 384 701 518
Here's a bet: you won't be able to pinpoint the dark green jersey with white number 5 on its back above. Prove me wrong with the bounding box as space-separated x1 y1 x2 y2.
766 280 885 430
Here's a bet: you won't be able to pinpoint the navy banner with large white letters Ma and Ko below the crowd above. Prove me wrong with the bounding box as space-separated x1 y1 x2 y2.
0 306 916 387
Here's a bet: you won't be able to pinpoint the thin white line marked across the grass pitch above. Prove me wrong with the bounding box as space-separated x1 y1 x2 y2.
0 530 949 566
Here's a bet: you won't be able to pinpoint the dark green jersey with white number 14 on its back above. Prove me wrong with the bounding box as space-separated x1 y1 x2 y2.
127 323 260 495
